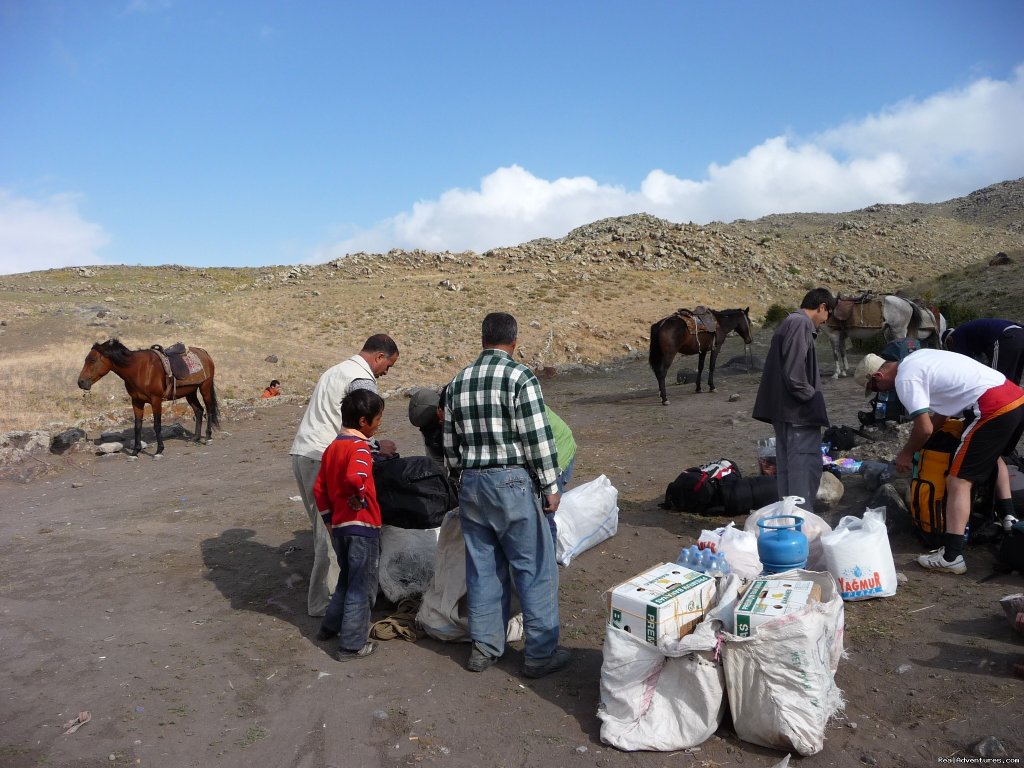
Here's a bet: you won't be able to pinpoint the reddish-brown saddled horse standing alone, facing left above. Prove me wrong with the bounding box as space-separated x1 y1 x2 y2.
78 339 220 456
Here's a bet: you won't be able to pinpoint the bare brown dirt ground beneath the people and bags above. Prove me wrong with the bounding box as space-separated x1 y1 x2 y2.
0 335 1024 768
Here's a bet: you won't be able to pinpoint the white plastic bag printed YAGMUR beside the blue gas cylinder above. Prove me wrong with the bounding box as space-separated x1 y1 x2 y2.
821 507 897 600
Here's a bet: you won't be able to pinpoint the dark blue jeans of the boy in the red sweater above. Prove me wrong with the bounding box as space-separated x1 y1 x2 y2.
322 530 381 650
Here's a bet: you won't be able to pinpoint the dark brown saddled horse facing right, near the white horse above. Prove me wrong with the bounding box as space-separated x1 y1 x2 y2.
647 307 754 406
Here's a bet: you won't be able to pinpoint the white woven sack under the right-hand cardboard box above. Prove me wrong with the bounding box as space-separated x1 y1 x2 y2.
722 570 844 755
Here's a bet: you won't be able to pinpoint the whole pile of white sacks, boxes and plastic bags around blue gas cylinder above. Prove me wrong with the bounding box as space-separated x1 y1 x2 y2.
598 497 897 755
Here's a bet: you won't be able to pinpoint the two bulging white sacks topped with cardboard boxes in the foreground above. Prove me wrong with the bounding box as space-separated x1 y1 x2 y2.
598 563 844 755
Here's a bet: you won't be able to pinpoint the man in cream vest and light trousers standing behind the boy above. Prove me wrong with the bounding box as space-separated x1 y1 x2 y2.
288 334 398 616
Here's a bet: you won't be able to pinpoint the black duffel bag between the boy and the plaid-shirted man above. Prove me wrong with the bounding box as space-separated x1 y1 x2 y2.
374 456 459 530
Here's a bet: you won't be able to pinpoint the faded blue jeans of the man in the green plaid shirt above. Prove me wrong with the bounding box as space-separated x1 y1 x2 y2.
459 467 558 660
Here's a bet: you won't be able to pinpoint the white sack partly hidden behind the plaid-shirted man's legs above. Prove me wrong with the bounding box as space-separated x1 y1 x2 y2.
416 508 522 643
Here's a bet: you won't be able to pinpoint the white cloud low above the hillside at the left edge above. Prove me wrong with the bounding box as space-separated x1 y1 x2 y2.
0 189 110 274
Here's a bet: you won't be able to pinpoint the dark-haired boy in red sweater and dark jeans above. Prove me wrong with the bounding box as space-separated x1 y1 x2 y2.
313 389 384 662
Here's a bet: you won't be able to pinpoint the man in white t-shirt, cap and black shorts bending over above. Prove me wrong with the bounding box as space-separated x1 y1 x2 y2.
864 349 1024 573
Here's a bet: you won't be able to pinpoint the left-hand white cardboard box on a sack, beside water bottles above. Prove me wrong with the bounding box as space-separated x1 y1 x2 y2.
608 563 715 645
